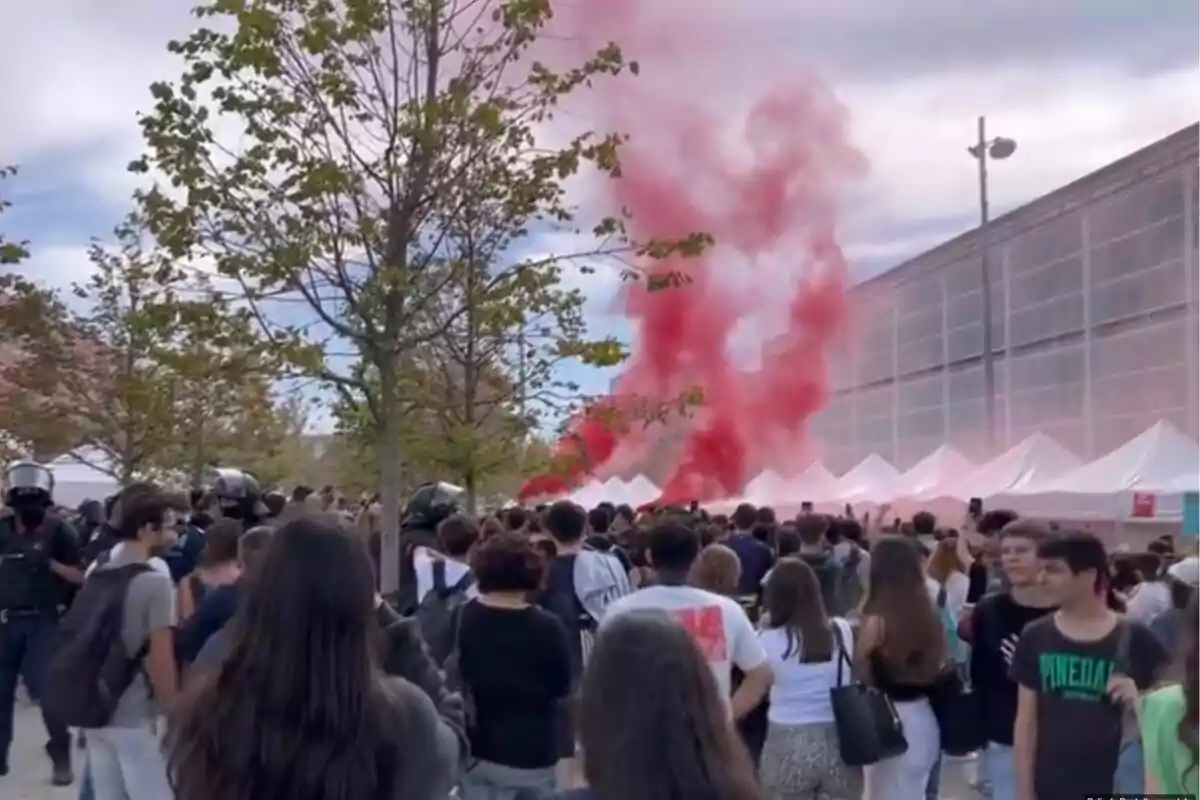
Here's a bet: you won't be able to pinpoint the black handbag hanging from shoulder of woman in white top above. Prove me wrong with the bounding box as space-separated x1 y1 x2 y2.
829 624 908 766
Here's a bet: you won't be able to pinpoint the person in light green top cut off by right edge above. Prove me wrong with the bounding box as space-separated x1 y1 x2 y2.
1139 595 1200 798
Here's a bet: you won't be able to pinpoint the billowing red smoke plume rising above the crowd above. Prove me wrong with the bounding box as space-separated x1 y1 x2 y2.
521 0 865 503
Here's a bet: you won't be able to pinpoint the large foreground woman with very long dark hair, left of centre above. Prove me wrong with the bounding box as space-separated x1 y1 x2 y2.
164 517 460 800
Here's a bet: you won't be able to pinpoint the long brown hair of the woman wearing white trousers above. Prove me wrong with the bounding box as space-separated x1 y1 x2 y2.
863 535 947 686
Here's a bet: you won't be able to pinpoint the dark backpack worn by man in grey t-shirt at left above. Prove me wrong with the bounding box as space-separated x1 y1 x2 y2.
42 564 151 728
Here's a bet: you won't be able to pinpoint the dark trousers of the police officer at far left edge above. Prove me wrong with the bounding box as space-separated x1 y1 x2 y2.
0 613 71 762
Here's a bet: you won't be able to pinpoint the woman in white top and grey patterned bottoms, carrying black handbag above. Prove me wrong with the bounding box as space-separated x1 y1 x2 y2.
758 558 863 800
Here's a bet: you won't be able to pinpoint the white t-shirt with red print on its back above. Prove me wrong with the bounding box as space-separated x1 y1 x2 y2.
601 587 767 698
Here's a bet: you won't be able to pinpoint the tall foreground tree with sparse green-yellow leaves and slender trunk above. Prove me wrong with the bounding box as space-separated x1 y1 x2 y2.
131 0 707 590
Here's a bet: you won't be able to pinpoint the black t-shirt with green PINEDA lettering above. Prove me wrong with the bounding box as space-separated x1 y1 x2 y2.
1009 614 1169 800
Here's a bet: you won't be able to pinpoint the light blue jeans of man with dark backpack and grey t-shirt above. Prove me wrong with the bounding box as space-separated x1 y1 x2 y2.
84 722 174 800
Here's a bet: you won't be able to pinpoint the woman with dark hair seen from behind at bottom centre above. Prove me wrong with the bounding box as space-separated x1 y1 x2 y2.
565 612 762 800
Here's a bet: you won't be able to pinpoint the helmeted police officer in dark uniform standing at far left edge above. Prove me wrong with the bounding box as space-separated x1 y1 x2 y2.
0 461 84 786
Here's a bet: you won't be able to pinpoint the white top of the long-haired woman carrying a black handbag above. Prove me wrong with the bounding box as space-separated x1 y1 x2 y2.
758 619 854 724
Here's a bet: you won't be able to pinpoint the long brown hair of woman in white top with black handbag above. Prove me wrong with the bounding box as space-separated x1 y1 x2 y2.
762 558 833 664
